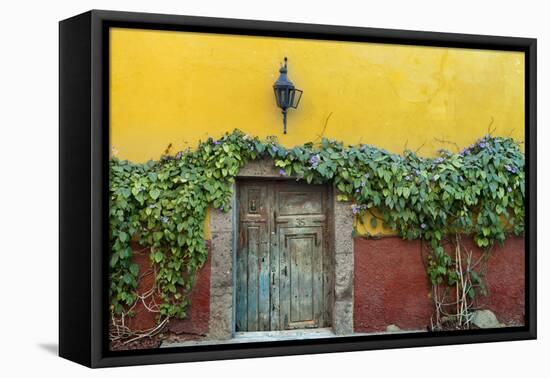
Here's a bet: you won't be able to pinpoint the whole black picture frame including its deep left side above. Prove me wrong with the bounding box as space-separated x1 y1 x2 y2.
59 10 537 368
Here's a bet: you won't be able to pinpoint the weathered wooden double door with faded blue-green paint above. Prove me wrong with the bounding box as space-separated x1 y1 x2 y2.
236 181 332 331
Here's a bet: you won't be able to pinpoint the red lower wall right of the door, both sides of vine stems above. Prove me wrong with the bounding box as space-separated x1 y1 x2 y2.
354 237 525 332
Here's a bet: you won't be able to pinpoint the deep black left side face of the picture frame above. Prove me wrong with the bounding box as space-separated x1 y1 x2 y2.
58 12 94 366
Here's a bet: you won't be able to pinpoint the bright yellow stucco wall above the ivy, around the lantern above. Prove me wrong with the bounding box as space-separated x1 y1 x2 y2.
110 28 524 235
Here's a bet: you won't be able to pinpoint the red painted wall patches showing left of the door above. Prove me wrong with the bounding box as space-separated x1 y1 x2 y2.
128 241 210 335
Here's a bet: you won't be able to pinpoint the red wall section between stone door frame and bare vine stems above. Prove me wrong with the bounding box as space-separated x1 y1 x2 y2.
353 237 432 332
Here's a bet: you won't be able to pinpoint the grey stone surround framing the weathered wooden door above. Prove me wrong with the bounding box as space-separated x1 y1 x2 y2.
207 159 354 340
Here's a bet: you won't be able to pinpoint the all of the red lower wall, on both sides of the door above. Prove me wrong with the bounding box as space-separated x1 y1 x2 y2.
123 237 525 335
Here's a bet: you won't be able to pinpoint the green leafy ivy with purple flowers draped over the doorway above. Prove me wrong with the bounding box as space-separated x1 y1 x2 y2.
110 130 525 324
